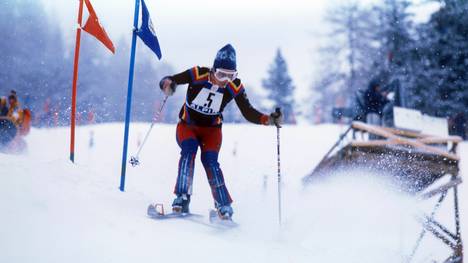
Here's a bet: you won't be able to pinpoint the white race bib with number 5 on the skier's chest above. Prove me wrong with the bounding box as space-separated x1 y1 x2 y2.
188 88 224 115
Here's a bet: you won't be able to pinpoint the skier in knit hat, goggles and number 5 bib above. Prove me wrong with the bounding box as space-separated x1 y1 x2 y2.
159 44 282 219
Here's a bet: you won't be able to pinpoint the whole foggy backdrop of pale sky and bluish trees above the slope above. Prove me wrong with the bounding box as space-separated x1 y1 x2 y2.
0 0 468 135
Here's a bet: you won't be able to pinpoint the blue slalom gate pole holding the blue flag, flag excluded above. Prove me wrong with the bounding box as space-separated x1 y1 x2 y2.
119 0 140 192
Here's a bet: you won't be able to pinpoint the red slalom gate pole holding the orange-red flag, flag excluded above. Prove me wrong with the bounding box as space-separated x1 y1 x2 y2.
70 0 83 163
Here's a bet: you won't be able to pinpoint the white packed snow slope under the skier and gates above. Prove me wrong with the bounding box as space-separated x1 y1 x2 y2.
0 124 468 263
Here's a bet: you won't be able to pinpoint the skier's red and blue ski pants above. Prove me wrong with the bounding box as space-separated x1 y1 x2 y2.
174 122 232 206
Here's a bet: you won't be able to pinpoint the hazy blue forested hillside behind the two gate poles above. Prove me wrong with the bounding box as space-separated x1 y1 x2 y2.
0 0 176 125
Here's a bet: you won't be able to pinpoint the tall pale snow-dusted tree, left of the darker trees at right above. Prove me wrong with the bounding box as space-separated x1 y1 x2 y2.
311 1 379 121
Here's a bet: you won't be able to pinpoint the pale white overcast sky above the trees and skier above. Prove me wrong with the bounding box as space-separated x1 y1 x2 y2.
43 0 438 107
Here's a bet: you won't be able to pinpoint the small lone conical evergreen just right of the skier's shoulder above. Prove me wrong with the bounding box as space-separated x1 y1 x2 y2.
262 49 296 123
